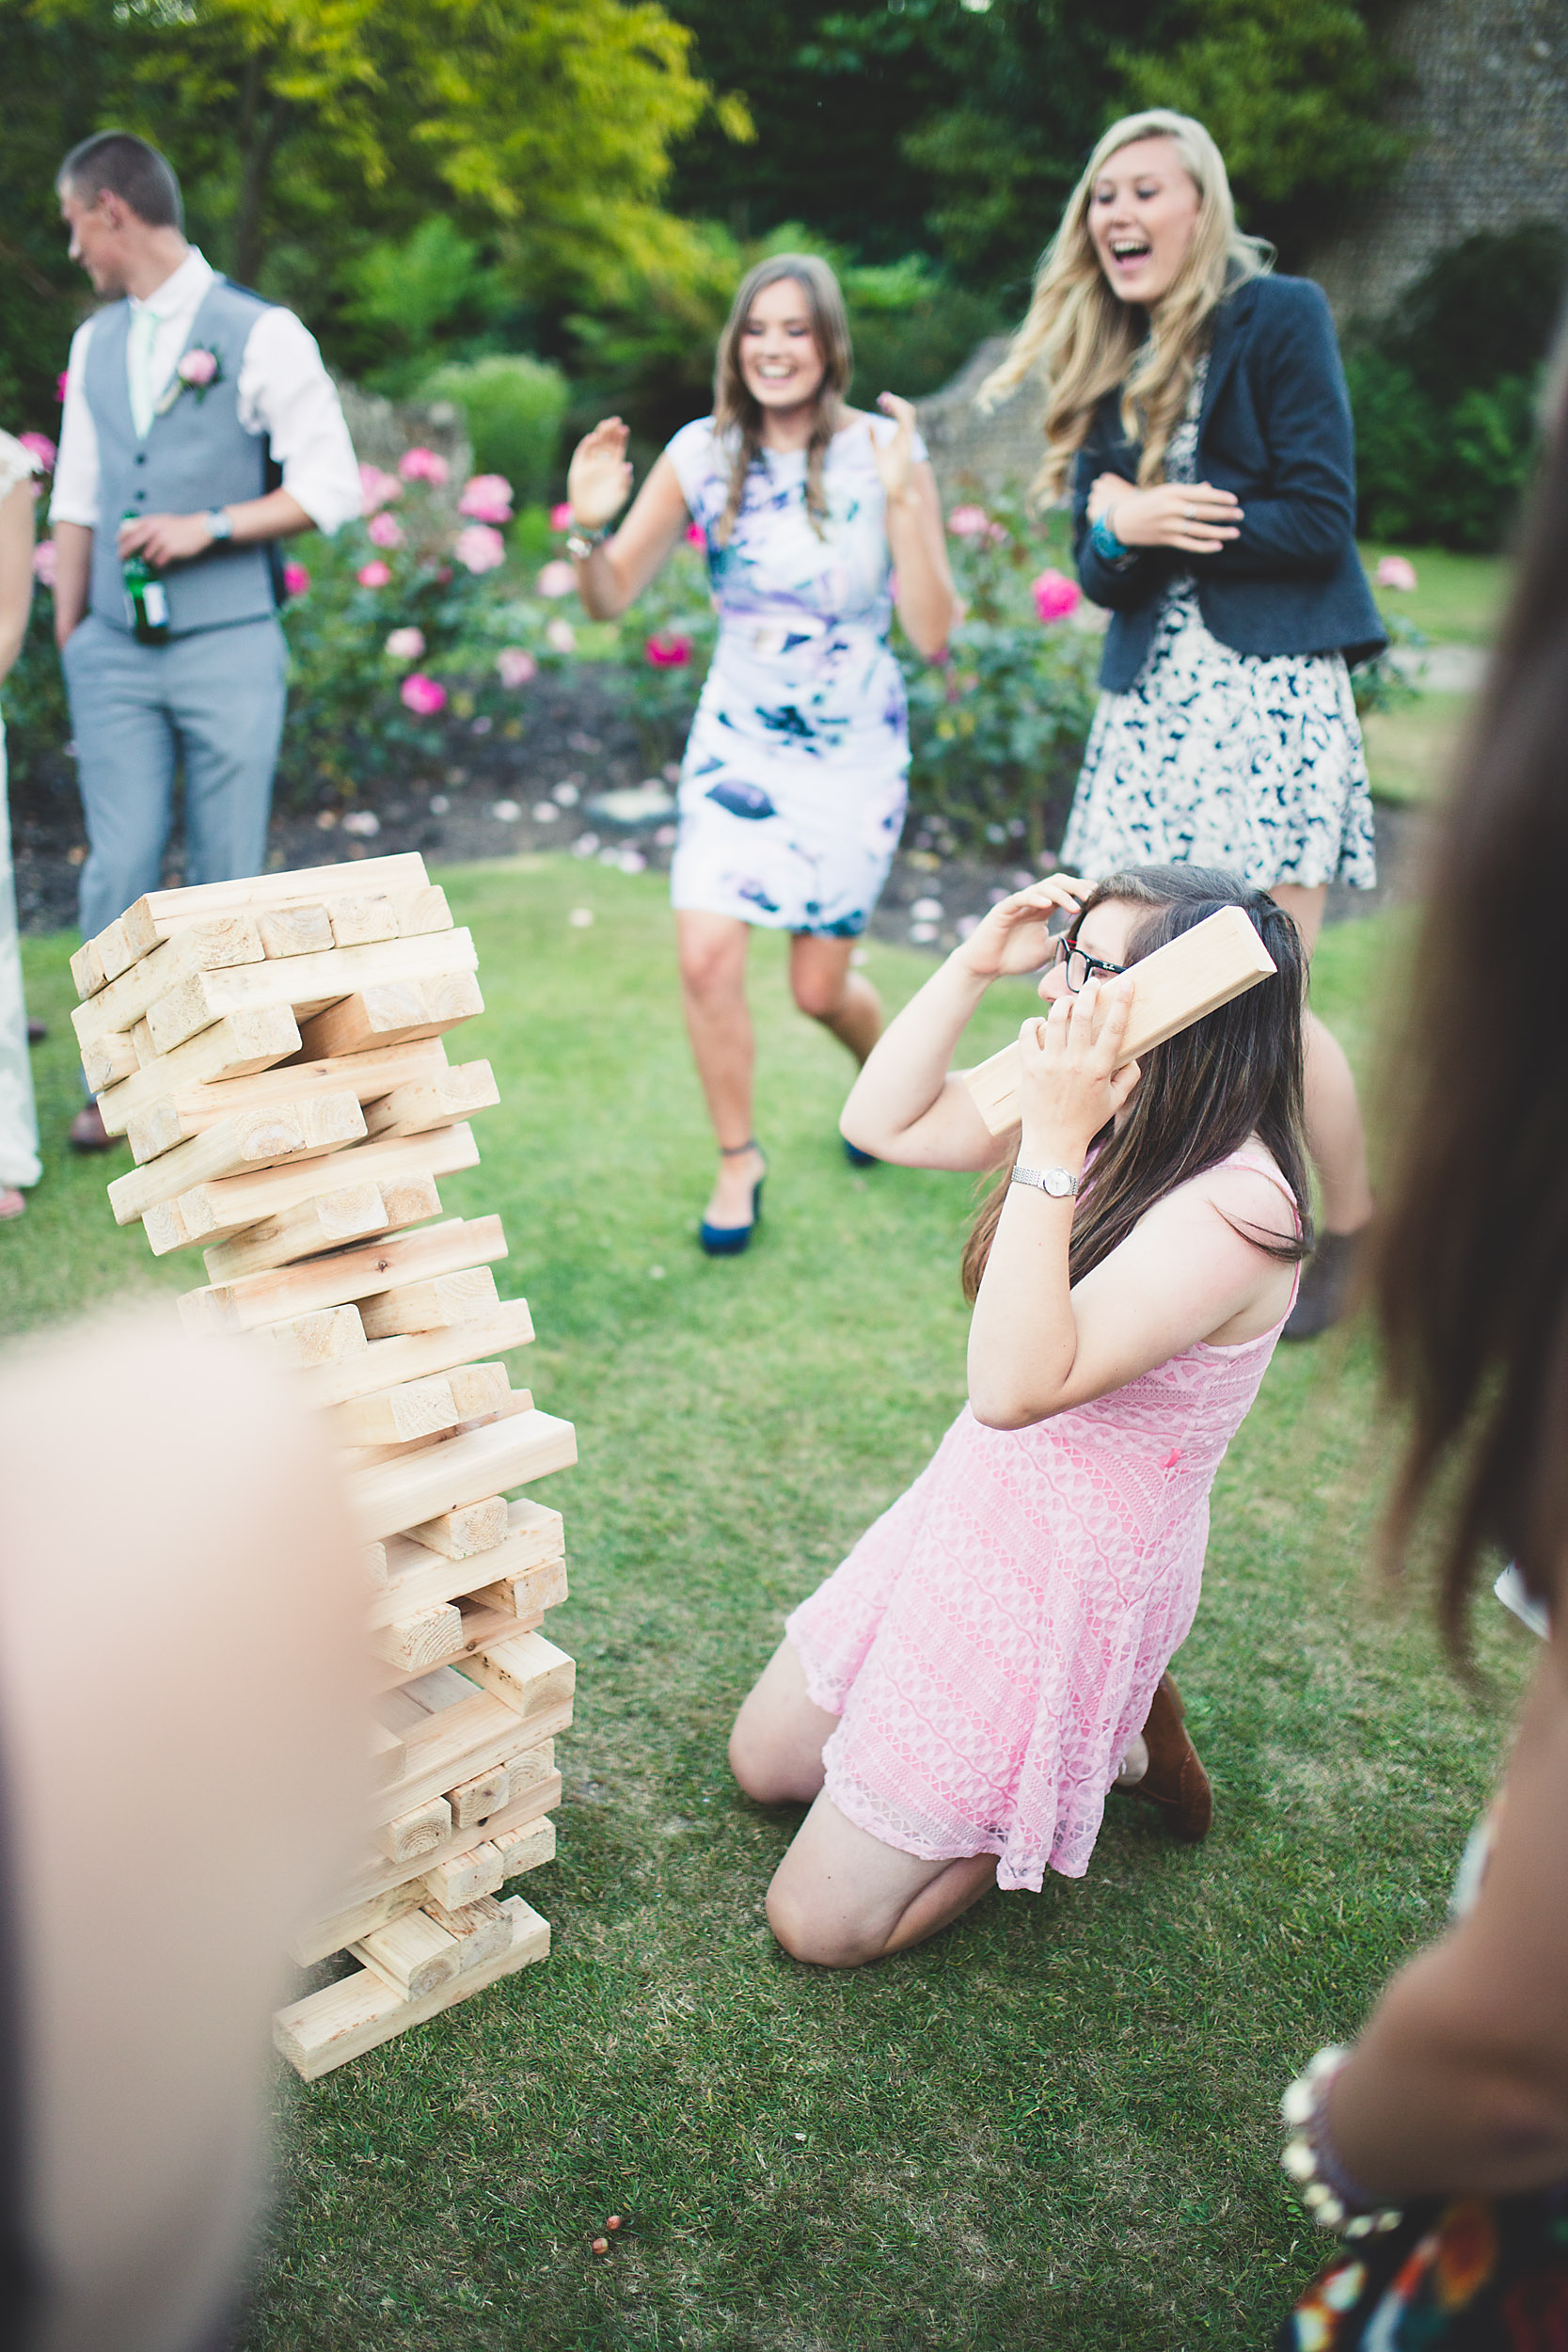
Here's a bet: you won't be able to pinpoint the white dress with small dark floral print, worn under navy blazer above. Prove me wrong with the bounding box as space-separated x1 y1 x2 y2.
1063 360 1378 889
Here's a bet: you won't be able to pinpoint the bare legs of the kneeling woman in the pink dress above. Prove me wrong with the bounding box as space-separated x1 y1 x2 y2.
729 1642 997 1969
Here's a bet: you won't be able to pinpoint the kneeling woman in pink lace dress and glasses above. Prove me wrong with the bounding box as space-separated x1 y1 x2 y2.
729 866 1307 1969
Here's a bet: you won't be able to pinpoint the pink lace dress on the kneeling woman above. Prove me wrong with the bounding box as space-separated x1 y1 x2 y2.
785 1152 1289 1894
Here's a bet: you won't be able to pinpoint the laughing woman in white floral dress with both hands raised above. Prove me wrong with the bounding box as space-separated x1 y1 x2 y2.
566 254 959 1256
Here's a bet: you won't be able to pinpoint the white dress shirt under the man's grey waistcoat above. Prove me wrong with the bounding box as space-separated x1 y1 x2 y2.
49 245 359 534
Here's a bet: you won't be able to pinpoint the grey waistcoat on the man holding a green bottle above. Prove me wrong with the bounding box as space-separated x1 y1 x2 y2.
82 278 277 638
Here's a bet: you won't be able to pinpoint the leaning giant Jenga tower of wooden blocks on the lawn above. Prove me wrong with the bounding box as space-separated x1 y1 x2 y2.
71 856 576 2079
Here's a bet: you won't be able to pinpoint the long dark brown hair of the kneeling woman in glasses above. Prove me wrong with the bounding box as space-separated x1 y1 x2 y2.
964 866 1312 1303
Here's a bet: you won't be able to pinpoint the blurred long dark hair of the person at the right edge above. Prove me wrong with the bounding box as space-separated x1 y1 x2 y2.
1373 348 1568 1661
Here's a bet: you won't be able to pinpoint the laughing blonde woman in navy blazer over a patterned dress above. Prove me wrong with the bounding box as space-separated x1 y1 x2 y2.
988 108 1385 1339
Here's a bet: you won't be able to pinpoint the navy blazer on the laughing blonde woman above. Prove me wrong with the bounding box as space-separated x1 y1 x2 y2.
1072 278 1387 694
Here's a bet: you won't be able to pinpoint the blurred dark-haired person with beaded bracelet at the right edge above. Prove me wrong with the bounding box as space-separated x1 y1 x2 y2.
1276 322 1568 2352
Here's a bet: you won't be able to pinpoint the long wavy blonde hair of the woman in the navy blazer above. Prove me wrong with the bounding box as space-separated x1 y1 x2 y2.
980 106 1275 501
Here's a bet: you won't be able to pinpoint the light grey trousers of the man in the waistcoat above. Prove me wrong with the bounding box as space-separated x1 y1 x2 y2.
61 614 287 939
